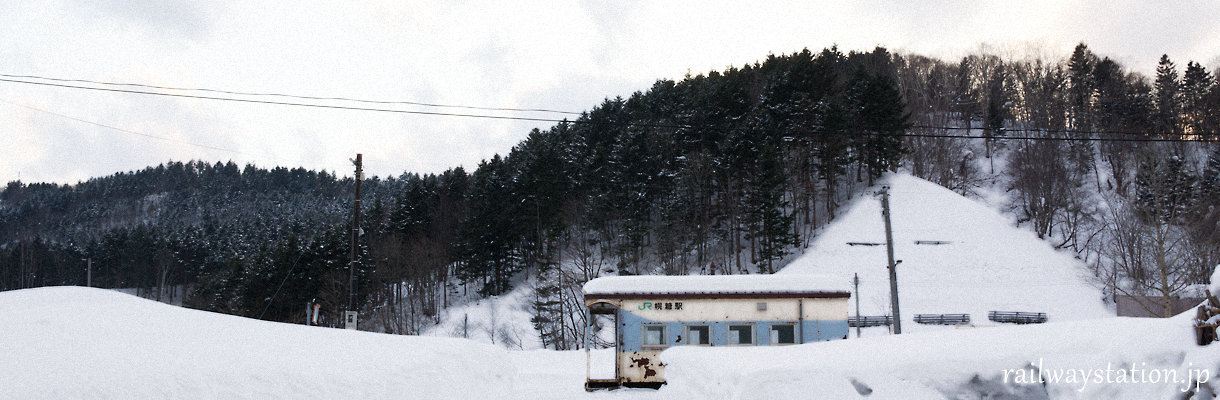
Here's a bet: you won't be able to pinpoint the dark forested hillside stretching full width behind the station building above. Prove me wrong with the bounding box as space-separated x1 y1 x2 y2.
0 45 1220 348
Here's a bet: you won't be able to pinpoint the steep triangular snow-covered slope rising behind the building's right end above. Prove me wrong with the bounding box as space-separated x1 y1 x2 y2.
780 174 1114 332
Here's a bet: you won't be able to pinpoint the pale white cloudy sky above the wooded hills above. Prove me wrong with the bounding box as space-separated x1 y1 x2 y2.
0 0 1220 183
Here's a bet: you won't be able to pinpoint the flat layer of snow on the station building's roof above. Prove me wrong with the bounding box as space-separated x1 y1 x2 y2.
584 274 850 296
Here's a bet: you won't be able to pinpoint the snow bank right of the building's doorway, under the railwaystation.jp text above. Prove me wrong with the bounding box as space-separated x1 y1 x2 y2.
661 315 1220 400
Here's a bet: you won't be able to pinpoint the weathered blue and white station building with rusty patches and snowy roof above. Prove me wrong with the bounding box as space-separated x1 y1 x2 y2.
584 274 850 389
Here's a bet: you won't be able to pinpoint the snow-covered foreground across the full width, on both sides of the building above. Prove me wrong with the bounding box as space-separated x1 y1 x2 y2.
0 288 1220 399
